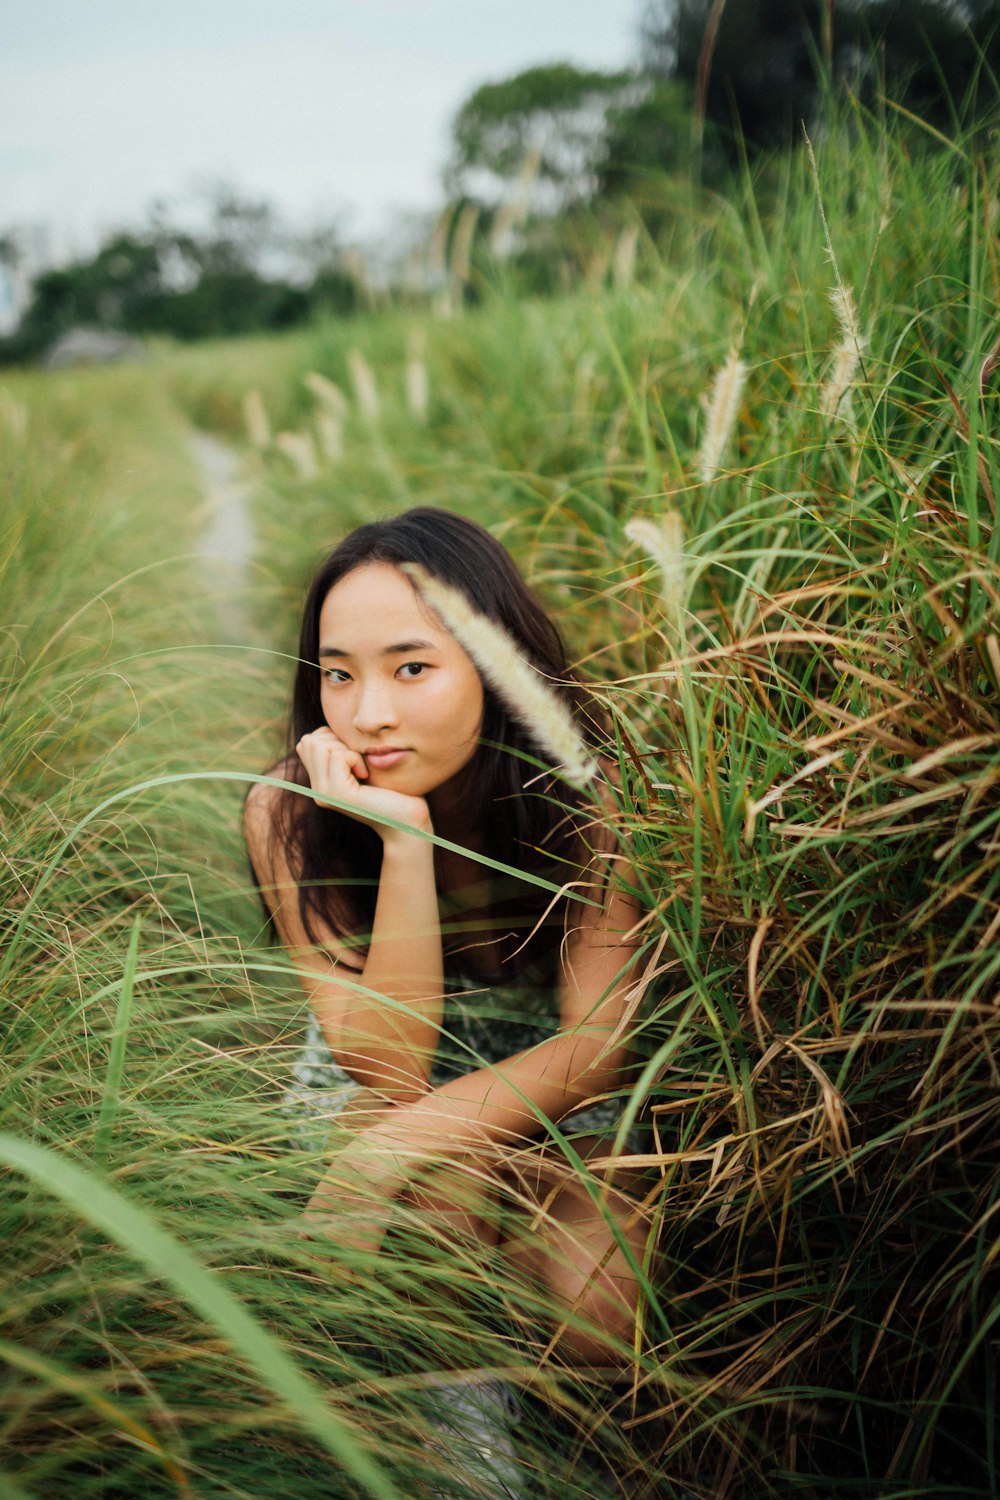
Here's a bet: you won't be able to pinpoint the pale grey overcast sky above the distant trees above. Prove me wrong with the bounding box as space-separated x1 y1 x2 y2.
0 0 642 255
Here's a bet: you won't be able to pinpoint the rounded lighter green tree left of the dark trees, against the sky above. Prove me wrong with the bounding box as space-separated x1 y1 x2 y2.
445 63 648 209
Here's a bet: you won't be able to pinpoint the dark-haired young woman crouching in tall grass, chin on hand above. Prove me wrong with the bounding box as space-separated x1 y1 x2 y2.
246 507 645 1494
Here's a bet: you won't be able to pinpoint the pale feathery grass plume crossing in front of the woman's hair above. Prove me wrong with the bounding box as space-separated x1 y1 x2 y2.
402 563 597 786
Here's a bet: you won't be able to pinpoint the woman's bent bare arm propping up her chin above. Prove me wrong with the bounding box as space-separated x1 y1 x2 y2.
244 750 444 1103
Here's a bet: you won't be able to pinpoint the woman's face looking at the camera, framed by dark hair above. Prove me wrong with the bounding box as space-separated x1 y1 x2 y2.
319 563 483 797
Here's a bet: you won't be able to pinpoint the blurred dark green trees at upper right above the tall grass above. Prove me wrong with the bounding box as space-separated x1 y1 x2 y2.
448 0 1000 207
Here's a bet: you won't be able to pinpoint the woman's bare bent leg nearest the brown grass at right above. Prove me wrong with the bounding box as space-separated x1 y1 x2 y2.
499 1137 649 1367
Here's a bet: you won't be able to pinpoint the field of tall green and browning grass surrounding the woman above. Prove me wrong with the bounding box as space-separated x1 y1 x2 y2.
0 108 1000 1500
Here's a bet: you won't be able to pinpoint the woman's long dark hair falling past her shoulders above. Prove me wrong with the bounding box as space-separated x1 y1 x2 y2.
263 506 598 972
